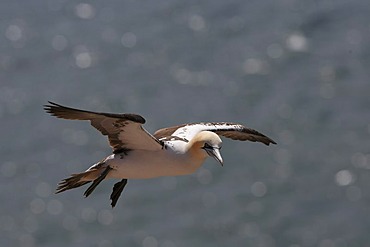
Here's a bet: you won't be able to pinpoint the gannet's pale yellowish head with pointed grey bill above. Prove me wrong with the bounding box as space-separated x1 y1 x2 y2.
189 131 224 166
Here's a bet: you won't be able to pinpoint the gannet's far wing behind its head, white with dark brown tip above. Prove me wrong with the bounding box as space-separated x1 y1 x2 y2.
154 122 276 145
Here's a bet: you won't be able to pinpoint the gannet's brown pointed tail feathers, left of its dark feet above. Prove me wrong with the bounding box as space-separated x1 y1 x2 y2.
55 169 101 194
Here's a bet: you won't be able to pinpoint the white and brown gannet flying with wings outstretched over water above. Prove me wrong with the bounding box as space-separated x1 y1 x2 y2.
44 101 276 207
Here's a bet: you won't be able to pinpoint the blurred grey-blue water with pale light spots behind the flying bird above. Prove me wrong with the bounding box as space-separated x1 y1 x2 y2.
0 0 370 247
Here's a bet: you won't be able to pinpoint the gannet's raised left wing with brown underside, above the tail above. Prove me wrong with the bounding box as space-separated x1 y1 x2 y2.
44 101 162 153
